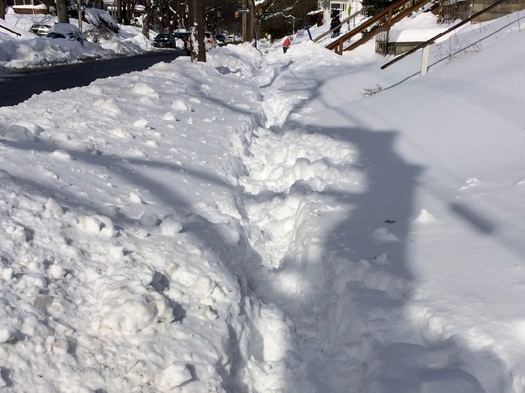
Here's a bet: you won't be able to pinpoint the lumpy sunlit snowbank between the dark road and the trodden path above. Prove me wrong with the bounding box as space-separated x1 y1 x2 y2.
0 43 278 392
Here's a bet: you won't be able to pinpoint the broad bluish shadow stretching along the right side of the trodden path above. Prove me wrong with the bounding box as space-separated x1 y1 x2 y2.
245 60 511 393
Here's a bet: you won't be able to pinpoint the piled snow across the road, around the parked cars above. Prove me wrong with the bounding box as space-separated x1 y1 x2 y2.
0 12 152 68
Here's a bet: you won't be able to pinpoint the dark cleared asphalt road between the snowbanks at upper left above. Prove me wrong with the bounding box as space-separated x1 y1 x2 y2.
0 50 184 107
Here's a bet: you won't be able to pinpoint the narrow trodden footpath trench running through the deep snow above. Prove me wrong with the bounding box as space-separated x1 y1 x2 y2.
227 50 413 392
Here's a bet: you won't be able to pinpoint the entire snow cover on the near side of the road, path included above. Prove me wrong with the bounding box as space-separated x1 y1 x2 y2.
0 8 525 393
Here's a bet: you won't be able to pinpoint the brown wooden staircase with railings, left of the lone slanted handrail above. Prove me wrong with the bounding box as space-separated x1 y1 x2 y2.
326 0 433 55
